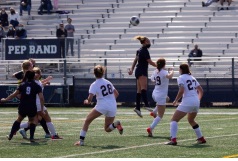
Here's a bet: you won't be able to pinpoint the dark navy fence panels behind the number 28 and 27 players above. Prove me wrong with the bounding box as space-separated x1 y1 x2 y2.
73 78 238 106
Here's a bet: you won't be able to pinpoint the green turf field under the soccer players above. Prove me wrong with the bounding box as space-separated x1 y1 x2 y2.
0 107 238 158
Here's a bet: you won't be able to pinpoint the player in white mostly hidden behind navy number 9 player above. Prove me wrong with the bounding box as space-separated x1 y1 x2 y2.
20 67 62 139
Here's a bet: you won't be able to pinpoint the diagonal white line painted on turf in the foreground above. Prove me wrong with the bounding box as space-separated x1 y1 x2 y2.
57 134 238 158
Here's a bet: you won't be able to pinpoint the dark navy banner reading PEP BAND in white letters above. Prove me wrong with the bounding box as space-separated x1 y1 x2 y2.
5 39 61 60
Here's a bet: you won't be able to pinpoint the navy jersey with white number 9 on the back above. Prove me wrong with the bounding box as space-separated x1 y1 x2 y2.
17 81 42 109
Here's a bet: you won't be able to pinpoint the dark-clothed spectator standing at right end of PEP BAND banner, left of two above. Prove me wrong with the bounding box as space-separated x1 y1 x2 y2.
56 23 67 58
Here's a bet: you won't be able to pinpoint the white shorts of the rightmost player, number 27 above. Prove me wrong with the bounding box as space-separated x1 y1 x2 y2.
177 97 200 113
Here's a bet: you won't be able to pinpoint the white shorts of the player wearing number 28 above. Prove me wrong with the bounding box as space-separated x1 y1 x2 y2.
95 104 117 117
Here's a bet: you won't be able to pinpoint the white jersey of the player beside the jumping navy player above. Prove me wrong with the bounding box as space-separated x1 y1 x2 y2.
151 69 169 98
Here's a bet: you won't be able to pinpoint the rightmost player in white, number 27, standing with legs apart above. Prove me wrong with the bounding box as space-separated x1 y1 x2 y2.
166 64 206 145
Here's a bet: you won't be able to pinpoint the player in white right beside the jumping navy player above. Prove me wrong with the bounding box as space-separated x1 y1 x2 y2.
147 58 174 137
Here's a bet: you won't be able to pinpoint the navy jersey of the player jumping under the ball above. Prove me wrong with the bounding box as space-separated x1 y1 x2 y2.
135 47 150 78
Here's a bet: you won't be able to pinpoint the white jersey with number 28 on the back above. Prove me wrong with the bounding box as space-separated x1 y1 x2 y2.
89 78 116 105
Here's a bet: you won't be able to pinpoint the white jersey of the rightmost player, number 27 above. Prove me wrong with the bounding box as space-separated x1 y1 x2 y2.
177 74 200 98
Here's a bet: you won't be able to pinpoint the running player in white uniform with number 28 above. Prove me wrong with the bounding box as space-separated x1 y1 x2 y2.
74 65 123 146
